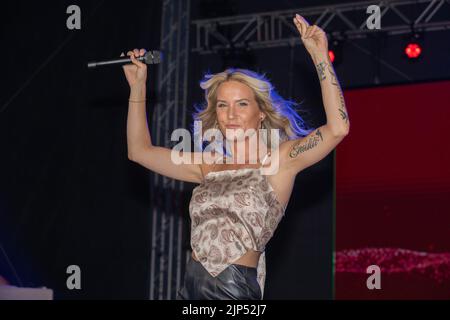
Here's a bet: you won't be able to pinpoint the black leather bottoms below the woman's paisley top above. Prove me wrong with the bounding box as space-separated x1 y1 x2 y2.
177 257 261 300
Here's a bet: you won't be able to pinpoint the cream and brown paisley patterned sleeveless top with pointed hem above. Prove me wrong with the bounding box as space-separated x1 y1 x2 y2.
189 155 286 294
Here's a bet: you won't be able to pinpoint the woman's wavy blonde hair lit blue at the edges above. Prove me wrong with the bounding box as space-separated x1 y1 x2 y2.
193 68 312 148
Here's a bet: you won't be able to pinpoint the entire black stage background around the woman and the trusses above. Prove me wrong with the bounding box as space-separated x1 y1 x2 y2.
0 0 450 299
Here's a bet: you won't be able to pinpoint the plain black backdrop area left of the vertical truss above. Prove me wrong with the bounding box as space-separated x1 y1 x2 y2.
0 1 161 299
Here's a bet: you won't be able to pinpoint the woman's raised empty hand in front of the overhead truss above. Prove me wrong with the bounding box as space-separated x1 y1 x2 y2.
294 14 328 57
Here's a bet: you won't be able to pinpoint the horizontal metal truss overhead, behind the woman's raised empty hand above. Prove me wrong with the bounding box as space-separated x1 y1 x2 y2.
191 0 450 54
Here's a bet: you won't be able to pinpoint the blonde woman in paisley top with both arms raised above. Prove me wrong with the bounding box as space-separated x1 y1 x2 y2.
124 15 349 300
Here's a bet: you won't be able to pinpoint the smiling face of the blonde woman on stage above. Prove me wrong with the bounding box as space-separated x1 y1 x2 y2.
216 80 265 140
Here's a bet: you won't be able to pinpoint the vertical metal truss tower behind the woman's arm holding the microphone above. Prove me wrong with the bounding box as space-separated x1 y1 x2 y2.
149 0 190 300
